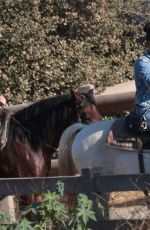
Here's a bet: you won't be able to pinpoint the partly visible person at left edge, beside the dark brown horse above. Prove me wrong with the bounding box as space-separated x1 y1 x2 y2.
0 95 10 150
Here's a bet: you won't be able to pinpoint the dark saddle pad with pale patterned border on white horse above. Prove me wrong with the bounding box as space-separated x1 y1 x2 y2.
106 118 141 151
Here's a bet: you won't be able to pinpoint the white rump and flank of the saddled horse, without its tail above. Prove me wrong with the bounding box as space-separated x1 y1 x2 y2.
72 120 150 175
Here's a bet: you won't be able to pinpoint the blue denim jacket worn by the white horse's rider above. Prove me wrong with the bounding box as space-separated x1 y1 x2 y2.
134 50 150 115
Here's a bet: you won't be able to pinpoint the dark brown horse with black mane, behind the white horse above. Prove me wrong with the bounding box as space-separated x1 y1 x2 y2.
0 90 100 204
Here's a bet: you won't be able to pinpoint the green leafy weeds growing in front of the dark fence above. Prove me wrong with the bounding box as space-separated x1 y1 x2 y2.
0 182 104 230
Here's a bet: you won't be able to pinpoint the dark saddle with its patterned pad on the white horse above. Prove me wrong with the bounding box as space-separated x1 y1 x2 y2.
106 118 150 152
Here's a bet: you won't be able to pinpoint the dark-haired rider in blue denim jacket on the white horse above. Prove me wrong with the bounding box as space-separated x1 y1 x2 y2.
134 22 150 130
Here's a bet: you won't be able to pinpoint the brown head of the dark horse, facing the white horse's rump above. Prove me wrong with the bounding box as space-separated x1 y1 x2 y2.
71 89 100 124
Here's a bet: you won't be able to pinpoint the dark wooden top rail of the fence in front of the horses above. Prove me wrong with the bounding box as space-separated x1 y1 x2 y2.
0 169 150 196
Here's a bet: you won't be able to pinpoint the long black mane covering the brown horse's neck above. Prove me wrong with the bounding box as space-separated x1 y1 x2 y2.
9 94 76 149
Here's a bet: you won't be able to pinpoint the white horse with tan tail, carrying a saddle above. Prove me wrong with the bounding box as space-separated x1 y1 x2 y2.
58 118 150 212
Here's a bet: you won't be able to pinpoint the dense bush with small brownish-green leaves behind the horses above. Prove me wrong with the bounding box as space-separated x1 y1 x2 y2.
0 0 150 104
